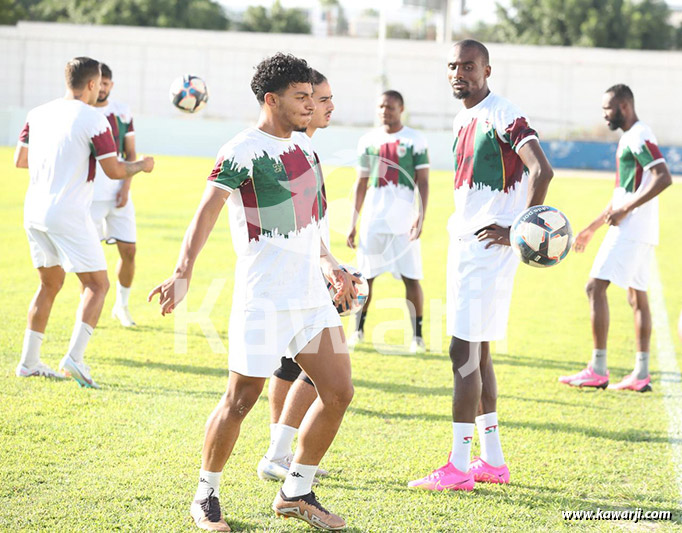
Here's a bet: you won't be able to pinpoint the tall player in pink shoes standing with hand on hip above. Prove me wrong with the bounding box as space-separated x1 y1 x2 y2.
409 39 553 490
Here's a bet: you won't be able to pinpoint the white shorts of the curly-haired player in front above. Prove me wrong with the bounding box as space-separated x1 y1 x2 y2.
228 299 341 378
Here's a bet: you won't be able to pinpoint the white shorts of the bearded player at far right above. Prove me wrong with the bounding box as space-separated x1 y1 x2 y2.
590 228 654 291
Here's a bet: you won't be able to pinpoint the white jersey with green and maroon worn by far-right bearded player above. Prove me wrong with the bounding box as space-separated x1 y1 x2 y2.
611 121 665 245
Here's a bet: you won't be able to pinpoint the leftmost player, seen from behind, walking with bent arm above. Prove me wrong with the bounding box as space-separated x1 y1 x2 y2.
14 57 154 388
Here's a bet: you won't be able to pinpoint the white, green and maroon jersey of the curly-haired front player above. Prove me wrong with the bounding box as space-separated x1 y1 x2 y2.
208 128 330 310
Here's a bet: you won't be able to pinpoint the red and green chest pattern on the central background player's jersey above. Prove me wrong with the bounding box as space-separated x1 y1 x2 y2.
360 139 429 189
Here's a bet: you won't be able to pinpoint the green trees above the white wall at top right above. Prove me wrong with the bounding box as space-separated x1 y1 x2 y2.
492 0 674 50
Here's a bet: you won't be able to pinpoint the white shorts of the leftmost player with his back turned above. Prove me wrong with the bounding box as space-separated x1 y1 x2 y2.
26 224 107 273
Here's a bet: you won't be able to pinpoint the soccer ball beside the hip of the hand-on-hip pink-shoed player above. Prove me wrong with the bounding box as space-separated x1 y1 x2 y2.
509 205 573 267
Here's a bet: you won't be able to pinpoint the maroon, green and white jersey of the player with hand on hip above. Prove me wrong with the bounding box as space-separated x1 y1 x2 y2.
450 93 538 235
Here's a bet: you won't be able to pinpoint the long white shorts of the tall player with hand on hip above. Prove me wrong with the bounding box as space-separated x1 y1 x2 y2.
447 235 519 342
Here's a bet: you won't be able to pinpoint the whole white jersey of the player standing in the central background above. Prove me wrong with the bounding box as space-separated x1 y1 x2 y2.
358 126 429 235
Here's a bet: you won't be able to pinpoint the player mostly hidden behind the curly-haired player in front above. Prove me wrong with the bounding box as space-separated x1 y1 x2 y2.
257 69 334 481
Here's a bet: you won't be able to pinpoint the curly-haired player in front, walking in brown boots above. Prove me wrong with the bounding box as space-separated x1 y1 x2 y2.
149 54 350 531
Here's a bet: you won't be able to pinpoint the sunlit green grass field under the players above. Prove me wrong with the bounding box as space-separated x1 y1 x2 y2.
0 143 682 532
